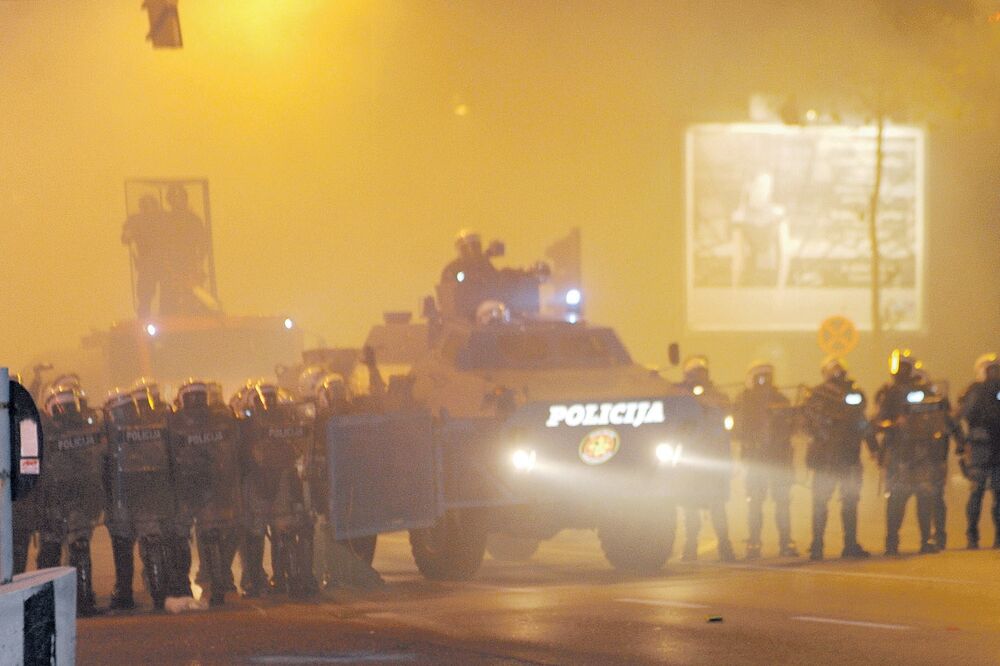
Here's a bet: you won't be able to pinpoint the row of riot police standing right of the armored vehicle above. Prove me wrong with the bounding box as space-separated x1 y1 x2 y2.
680 350 1000 561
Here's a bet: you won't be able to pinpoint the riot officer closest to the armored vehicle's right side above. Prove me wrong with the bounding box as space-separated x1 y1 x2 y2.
678 356 735 562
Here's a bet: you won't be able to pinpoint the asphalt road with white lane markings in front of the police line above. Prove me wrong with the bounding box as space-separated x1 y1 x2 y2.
66 452 1000 666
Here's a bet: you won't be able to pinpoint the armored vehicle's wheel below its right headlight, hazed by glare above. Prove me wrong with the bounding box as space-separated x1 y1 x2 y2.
597 503 677 574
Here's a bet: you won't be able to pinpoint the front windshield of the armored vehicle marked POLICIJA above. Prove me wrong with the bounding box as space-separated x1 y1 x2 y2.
456 326 631 370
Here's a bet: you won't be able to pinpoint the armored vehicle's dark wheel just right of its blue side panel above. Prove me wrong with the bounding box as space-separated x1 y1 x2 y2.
410 511 486 580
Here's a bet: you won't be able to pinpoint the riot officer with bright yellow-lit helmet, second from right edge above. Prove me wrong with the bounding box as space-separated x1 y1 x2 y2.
874 349 948 556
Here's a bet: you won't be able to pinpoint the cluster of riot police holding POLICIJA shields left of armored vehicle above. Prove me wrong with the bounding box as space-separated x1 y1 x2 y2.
14 368 364 615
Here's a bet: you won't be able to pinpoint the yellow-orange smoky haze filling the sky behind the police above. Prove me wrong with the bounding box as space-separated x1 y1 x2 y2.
0 0 1000 392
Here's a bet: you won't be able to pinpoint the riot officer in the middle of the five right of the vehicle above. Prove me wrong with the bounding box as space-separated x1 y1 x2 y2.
802 358 876 560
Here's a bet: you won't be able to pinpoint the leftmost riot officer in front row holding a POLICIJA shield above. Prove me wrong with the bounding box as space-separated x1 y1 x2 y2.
35 383 108 616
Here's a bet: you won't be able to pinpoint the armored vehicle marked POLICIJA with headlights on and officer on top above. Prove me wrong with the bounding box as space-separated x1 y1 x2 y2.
326 239 706 579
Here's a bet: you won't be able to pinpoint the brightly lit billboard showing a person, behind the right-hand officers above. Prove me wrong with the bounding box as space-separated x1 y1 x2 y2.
687 124 923 330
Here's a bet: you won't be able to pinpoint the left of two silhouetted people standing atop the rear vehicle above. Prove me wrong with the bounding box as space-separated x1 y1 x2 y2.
122 194 167 319
